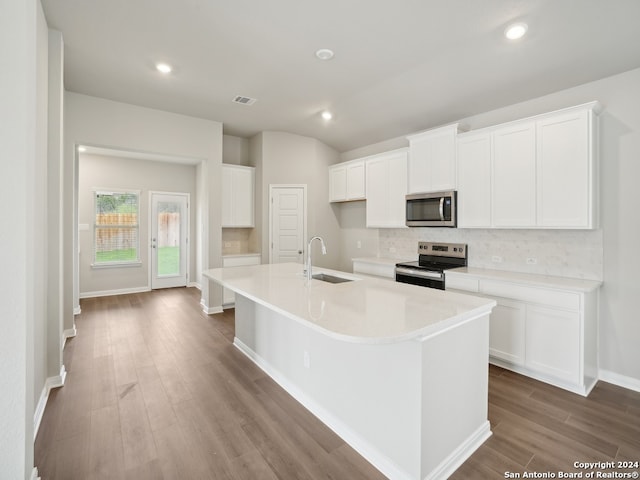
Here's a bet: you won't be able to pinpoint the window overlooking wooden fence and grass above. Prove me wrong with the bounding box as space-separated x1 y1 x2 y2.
93 191 140 266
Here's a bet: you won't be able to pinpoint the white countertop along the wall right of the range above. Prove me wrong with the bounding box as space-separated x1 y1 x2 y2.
445 267 602 292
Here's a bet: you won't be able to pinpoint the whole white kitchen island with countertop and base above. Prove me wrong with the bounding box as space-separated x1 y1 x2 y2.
204 264 495 479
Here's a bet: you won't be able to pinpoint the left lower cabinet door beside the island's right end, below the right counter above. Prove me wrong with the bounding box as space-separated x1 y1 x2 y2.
489 299 526 365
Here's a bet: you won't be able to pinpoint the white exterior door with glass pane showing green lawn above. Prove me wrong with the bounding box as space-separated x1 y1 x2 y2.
149 192 189 289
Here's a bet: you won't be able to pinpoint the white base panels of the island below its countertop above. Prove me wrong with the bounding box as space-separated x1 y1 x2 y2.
234 292 491 480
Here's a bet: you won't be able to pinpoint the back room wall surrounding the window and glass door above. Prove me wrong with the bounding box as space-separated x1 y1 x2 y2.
78 154 196 298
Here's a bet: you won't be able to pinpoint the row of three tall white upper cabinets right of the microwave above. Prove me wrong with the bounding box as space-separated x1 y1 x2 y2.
456 102 599 229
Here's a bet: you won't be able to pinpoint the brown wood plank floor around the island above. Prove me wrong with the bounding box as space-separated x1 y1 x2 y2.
35 288 640 480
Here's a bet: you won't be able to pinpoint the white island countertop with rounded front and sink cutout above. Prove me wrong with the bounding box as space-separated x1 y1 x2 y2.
203 263 496 343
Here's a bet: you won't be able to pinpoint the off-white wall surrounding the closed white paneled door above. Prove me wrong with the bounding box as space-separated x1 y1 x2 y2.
251 132 340 268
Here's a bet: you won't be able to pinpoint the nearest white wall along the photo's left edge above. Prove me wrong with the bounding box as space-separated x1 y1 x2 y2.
0 0 48 479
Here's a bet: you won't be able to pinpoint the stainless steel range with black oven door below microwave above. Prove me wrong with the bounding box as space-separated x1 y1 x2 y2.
396 242 468 290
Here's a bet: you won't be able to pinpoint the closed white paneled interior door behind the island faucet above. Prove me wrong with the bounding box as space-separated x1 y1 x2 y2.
269 185 306 263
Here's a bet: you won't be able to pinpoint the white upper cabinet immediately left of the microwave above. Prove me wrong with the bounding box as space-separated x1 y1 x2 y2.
366 149 407 228
